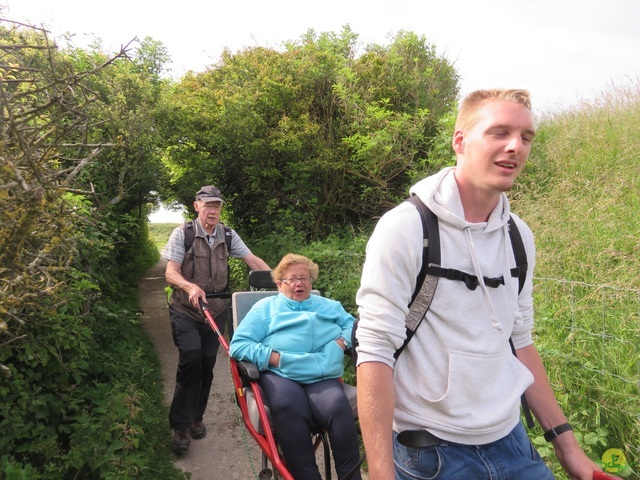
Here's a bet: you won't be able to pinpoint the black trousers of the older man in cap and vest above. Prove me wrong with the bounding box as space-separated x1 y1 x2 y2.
169 308 228 429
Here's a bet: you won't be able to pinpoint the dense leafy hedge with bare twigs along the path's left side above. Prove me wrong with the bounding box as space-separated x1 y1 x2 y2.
0 20 179 480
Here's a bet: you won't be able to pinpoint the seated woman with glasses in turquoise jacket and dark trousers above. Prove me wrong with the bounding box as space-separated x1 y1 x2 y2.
229 254 361 480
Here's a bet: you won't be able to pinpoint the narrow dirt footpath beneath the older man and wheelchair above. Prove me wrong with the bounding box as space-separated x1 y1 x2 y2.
139 260 261 480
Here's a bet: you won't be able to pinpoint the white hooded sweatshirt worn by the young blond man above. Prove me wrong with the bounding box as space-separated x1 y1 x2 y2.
356 167 535 445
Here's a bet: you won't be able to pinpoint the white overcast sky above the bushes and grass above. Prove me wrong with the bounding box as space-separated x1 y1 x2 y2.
0 0 640 221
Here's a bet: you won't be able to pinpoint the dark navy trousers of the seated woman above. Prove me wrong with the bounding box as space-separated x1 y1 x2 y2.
258 372 361 480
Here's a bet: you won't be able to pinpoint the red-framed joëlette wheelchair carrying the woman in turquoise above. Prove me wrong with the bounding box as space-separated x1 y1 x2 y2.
200 270 364 480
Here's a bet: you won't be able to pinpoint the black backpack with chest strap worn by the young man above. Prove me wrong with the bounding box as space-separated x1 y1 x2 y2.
351 195 533 428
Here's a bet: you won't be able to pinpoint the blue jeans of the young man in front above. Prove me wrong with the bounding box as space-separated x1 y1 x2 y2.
393 423 553 480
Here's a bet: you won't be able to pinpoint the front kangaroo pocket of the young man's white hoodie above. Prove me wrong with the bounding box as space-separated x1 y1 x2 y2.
421 349 533 433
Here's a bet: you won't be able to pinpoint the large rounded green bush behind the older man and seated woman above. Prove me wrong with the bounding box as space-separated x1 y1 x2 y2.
164 27 458 240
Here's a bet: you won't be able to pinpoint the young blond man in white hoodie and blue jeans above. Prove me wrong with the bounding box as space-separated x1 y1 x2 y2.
356 90 598 480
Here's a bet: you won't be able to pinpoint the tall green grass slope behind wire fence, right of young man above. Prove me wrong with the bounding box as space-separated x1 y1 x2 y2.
512 83 640 479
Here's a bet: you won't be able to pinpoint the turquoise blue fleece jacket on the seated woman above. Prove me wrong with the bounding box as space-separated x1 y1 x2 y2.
229 293 354 384
